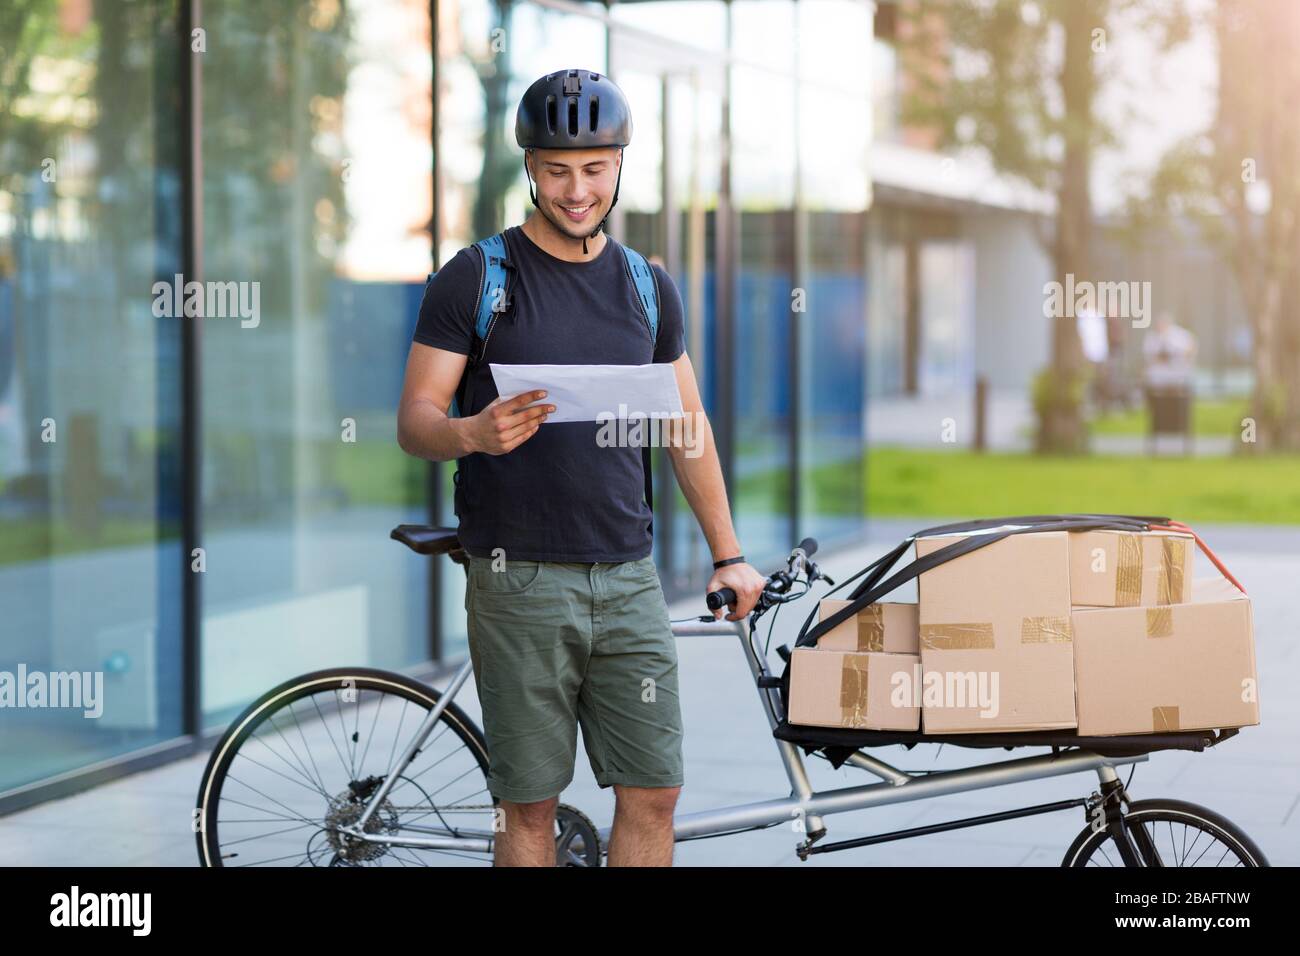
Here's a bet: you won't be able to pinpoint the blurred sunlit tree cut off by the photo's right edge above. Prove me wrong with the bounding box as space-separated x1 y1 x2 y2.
1130 0 1300 451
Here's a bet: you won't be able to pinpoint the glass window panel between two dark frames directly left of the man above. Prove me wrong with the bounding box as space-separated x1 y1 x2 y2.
202 0 432 722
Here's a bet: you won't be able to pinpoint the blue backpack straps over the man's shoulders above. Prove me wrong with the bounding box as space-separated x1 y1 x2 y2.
429 233 659 533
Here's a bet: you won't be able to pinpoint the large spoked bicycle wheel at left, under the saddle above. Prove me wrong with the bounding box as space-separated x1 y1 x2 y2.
195 667 497 866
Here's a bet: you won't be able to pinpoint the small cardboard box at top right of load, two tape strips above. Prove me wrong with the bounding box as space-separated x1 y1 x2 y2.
1070 529 1196 607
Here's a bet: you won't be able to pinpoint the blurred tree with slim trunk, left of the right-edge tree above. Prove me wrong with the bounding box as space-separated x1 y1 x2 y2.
900 0 1186 453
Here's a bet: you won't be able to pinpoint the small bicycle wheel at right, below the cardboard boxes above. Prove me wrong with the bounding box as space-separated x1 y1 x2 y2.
1061 800 1269 868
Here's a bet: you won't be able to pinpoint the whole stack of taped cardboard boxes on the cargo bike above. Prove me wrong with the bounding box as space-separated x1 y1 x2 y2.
789 531 1260 736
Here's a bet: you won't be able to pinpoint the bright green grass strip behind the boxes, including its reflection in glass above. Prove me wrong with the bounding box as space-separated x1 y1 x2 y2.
737 449 1300 524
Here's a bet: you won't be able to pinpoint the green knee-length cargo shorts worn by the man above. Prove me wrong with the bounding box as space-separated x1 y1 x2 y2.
465 557 684 803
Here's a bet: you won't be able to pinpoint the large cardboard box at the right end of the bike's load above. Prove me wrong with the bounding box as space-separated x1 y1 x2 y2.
1073 578 1260 736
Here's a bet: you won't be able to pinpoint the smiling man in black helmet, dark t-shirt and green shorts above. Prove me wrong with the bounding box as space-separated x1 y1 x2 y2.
398 70 764 866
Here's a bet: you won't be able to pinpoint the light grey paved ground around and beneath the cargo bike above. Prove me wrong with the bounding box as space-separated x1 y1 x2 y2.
0 519 1300 866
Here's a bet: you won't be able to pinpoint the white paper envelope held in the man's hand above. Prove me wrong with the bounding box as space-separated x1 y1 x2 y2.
488 362 683 424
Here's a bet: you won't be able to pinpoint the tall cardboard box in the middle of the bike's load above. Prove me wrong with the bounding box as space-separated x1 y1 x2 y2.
917 531 1075 734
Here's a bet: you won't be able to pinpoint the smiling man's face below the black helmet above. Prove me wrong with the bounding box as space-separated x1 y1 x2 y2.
530 147 623 239
